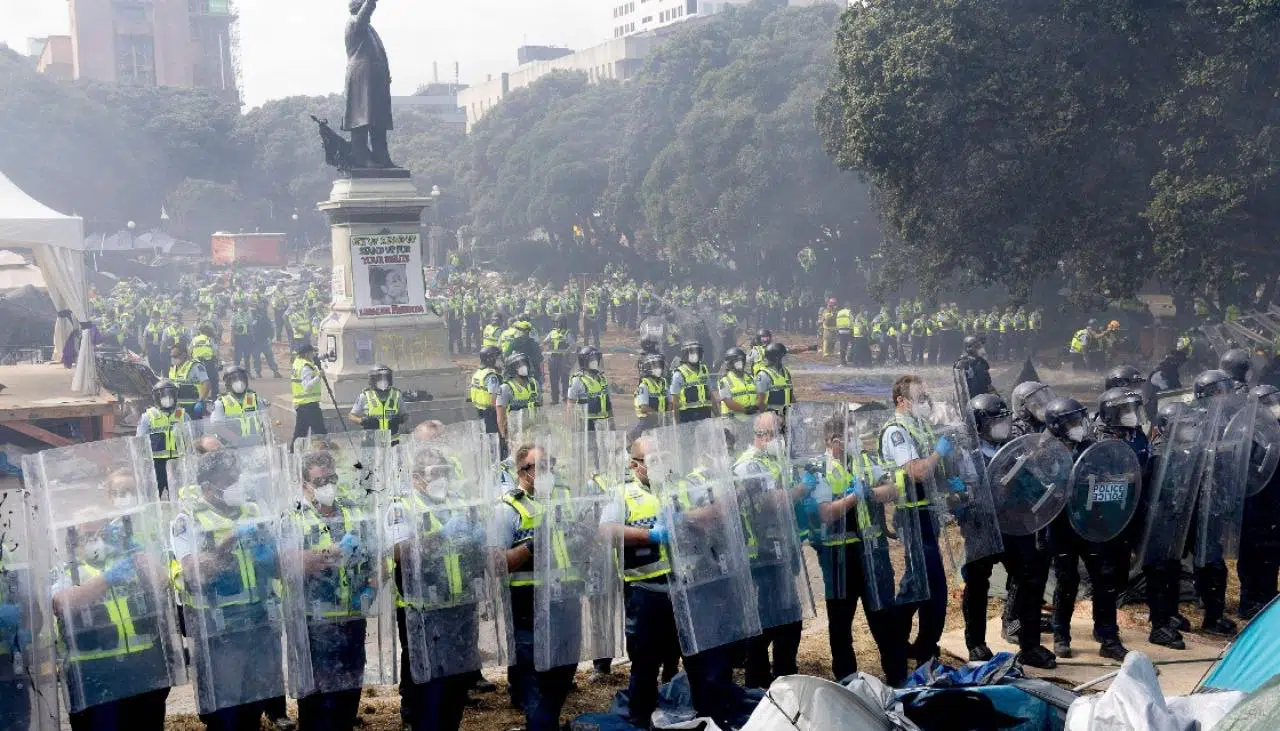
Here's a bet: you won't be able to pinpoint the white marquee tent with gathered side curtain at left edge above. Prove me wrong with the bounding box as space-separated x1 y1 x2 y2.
0 173 99 396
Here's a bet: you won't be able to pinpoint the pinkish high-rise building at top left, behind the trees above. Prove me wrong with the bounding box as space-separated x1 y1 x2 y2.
69 0 239 100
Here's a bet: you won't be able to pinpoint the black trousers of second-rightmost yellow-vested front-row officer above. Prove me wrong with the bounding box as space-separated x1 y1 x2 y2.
818 543 906 686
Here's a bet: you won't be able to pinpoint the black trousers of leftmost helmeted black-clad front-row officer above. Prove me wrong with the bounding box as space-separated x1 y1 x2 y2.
960 534 1050 652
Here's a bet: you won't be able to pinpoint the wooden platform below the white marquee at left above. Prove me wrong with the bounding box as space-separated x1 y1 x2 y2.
0 364 115 447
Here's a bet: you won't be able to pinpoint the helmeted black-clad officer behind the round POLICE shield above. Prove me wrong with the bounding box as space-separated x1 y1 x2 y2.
1044 398 1129 661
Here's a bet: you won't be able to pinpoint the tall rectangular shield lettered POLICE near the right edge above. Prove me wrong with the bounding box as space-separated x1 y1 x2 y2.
1196 394 1258 566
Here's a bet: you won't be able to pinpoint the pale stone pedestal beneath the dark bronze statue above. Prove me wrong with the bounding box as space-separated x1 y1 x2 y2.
316 169 466 417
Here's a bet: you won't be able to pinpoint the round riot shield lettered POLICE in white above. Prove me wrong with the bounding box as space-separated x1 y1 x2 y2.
984 433 1073 535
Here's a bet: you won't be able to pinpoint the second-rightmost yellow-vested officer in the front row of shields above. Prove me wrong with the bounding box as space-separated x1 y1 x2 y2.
805 415 906 685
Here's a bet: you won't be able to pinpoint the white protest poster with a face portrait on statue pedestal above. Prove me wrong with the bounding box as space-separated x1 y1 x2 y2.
351 233 426 317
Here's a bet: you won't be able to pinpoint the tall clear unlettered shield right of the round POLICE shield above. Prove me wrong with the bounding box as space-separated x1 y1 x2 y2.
1138 408 1212 566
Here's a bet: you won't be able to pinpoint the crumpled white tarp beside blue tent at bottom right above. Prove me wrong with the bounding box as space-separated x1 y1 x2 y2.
1066 652 1244 731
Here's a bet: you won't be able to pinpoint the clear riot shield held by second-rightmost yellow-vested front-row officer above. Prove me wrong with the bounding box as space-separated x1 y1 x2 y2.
850 410 932 611
